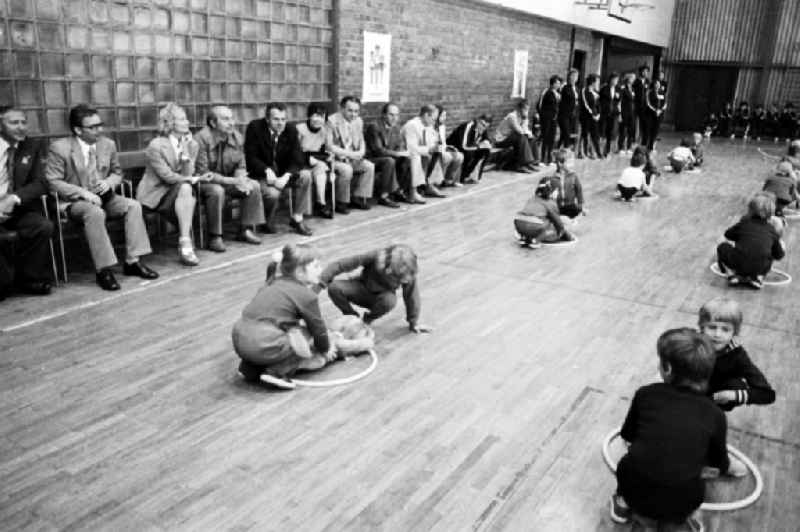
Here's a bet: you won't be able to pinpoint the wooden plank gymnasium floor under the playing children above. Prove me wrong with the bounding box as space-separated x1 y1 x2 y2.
0 137 800 531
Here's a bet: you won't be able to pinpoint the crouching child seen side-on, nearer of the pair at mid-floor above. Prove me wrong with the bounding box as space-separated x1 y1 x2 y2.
514 177 575 246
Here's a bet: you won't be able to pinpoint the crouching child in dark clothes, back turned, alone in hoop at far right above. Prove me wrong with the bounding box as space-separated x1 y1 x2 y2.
717 192 786 288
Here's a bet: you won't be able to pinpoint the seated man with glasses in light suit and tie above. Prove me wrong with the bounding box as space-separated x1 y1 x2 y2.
46 104 158 290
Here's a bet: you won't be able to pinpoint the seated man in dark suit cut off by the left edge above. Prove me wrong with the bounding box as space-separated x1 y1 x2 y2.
0 106 53 300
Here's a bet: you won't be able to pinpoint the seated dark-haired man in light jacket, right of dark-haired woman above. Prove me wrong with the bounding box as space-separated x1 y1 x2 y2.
326 96 376 210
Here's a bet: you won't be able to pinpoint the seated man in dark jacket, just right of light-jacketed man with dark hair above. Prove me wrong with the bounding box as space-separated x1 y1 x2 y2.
366 102 410 207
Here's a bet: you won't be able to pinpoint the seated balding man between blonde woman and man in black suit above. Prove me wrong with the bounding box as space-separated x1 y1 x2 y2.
194 105 266 251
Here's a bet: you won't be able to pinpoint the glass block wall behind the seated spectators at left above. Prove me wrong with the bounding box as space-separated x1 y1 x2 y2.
0 0 334 151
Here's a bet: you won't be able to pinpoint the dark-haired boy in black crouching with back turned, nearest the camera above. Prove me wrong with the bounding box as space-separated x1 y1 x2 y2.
611 328 729 530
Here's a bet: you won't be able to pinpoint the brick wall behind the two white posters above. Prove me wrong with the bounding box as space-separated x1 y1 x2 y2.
337 0 600 126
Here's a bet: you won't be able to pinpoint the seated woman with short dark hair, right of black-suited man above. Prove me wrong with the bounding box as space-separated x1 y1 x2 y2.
297 103 353 218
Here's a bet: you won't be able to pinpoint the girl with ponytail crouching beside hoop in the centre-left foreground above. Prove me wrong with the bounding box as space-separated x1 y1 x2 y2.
232 244 336 390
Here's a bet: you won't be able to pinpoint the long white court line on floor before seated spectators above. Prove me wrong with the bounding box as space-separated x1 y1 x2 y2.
0 169 550 334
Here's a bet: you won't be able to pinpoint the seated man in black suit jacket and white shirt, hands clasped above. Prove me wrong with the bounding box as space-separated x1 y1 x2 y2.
244 102 312 236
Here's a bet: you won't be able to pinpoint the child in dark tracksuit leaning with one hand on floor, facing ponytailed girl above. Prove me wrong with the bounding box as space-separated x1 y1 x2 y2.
320 244 430 332
